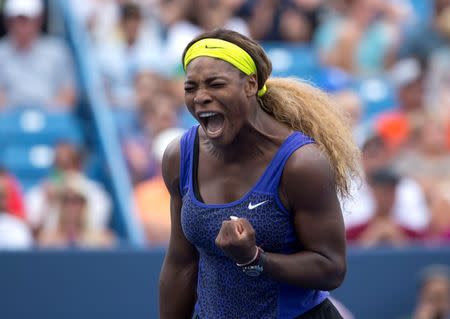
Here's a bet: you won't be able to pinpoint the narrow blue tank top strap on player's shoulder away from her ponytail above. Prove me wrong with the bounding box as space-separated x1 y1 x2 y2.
180 125 198 195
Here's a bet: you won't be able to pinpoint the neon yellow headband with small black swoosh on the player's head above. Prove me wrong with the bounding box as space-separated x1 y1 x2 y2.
184 38 267 97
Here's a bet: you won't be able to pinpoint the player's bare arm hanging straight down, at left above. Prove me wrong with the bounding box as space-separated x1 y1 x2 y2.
159 140 198 319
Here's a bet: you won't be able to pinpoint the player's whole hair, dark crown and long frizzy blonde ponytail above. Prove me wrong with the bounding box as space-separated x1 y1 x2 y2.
182 29 360 198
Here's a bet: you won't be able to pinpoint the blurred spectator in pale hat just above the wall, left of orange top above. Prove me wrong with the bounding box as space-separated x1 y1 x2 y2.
38 175 114 248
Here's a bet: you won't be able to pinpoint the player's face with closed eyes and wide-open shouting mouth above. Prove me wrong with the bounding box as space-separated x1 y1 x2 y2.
184 57 258 145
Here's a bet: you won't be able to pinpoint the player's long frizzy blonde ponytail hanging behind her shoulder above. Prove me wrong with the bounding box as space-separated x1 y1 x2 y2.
260 78 360 198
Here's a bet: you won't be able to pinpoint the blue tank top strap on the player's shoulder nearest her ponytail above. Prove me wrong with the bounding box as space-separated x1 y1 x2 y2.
256 132 315 194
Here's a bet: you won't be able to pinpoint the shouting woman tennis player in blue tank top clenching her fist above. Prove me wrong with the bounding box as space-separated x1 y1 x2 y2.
160 30 358 319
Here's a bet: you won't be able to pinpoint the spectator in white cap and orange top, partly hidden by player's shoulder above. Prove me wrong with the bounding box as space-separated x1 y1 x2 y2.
134 129 183 246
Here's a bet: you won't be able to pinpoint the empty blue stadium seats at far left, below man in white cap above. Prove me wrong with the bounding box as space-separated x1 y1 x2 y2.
0 108 83 189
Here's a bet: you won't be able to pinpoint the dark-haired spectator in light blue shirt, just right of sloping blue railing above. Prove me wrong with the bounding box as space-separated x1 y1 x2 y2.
96 2 166 108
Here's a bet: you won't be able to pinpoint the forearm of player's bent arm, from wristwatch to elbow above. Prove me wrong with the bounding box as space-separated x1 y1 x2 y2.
264 251 346 290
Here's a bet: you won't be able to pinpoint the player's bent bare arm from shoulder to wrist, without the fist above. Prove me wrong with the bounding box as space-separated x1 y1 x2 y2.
264 144 346 290
